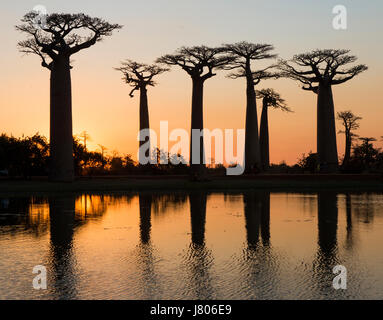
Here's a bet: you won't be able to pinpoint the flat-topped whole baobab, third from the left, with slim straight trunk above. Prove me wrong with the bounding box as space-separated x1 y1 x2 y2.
157 46 231 179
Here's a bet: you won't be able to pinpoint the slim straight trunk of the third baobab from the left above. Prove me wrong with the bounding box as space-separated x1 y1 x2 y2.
190 79 205 179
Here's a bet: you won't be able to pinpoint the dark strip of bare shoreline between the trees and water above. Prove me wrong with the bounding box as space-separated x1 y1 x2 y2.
0 174 383 195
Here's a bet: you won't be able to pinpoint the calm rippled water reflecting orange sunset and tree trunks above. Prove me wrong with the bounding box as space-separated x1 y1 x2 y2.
0 191 383 299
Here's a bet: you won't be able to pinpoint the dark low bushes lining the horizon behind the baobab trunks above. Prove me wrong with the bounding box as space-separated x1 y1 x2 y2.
0 133 383 179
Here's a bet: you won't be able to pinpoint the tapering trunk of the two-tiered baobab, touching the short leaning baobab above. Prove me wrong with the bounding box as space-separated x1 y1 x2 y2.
245 72 262 173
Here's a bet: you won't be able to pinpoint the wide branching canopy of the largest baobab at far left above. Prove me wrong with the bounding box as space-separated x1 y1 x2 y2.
16 12 122 69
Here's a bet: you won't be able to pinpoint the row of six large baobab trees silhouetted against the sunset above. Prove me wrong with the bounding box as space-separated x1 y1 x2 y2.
16 12 367 181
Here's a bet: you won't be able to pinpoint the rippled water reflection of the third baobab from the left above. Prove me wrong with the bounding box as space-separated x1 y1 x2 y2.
184 192 215 300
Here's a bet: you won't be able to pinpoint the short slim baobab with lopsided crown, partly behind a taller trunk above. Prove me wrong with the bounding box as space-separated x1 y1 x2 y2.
256 89 291 170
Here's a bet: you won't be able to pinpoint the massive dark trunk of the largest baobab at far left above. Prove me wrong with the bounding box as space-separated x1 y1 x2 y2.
50 57 74 182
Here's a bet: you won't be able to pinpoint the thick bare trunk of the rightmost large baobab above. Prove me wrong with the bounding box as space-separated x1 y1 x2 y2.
317 84 338 172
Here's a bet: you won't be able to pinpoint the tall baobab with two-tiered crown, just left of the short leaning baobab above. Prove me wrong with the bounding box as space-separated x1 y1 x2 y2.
224 41 278 173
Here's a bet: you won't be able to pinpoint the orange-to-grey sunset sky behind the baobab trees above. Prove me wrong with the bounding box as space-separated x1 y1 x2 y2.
0 0 383 163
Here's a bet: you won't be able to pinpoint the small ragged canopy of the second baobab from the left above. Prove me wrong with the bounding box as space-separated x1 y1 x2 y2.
116 60 169 97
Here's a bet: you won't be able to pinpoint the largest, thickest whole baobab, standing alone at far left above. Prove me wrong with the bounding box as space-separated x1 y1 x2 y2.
16 12 121 181
